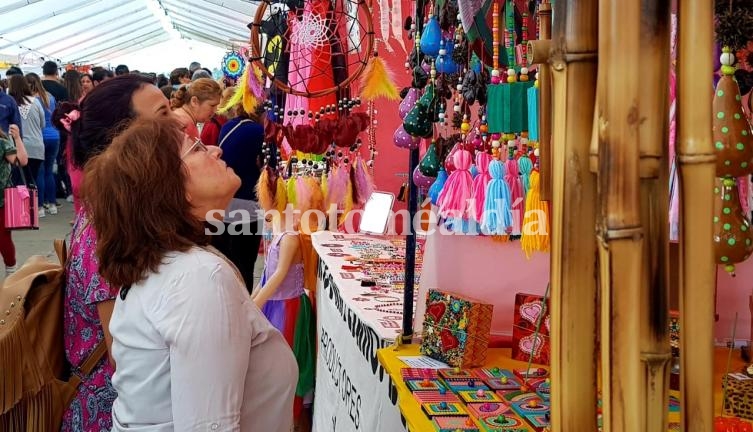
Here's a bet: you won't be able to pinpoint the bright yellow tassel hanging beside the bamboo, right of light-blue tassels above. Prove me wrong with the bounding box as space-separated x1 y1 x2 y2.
520 171 549 258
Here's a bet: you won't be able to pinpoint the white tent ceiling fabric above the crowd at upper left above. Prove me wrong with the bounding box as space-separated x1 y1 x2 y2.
0 0 257 64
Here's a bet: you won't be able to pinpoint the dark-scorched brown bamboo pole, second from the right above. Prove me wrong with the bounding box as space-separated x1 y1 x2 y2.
639 0 672 432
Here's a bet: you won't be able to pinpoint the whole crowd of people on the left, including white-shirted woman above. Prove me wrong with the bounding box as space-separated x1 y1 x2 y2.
0 62 315 432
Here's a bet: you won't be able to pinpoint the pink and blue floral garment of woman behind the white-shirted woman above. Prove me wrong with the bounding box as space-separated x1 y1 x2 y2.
61 211 117 432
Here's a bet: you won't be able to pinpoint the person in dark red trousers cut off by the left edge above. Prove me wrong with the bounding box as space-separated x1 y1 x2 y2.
0 125 28 277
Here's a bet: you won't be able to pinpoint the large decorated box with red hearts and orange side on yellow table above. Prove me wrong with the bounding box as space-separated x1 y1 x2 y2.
421 290 494 368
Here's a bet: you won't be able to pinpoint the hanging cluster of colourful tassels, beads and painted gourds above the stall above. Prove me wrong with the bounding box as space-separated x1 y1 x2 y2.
394 0 549 257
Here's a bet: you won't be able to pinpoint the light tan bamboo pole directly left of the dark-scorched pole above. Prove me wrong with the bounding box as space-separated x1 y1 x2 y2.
597 0 651 426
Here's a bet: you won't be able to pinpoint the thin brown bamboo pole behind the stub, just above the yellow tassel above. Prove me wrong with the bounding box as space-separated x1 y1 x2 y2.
539 0 552 201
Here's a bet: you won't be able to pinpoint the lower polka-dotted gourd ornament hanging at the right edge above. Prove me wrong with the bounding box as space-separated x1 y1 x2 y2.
714 178 753 274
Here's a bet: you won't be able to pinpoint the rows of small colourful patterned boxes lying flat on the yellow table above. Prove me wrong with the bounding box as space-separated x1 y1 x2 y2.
402 367 549 432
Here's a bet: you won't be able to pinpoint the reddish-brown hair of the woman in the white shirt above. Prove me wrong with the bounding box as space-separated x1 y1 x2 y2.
82 119 209 287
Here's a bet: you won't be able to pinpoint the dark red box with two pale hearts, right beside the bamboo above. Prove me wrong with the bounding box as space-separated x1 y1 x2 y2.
512 293 551 365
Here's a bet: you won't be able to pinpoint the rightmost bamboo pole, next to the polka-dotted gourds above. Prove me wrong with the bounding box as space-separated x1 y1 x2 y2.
677 0 716 432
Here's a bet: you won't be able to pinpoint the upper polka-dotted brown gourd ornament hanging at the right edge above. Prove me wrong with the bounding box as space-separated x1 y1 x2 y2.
713 47 753 177
